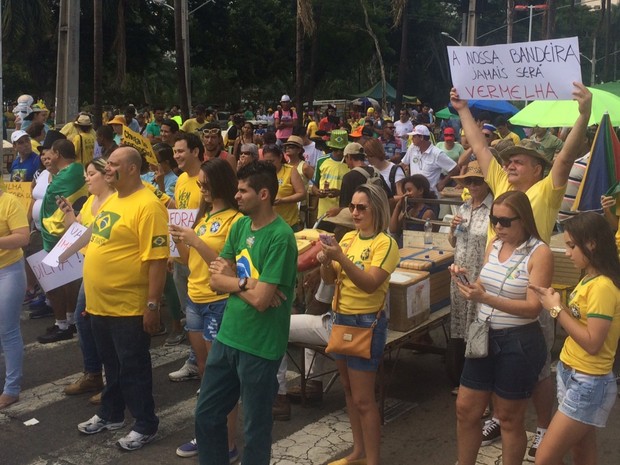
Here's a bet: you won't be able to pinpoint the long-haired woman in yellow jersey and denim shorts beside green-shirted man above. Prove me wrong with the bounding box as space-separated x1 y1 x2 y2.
170 158 243 459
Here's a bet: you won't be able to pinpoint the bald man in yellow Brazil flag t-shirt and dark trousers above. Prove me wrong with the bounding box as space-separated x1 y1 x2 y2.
78 147 169 450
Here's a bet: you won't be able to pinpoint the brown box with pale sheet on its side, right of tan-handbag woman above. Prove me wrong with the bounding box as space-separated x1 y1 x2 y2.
388 268 431 331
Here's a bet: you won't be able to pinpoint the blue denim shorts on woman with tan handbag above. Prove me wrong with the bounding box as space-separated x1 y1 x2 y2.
332 312 387 371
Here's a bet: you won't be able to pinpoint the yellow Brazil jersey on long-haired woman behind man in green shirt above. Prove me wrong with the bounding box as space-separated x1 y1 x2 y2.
187 208 243 303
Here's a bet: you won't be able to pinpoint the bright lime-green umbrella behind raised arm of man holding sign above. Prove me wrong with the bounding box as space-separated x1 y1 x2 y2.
509 87 620 128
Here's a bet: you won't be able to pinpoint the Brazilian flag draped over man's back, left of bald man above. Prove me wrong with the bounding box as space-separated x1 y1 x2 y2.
41 163 88 252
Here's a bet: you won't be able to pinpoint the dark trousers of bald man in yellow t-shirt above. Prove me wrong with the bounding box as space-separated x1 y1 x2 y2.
90 315 159 434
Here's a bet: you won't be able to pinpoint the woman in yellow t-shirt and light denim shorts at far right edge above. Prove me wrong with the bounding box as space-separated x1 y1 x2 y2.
530 212 620 465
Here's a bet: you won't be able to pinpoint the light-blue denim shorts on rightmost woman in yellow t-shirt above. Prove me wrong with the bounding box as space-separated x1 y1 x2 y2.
557 361 618 428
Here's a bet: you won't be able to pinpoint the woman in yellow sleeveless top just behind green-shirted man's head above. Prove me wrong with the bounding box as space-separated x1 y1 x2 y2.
263 144 306 231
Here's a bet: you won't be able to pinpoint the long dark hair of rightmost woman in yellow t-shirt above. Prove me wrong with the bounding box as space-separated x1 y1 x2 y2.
563 212 620 288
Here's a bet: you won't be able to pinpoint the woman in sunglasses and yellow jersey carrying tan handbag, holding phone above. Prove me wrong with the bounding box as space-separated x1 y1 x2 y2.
317 184 399 465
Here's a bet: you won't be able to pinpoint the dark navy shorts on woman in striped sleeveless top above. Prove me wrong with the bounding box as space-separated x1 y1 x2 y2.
461 321 547 400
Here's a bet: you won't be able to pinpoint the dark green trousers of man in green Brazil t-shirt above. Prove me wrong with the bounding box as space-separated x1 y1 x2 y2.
196 339 281 465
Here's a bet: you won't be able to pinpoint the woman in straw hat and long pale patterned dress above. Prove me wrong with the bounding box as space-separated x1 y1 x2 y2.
446 161 493 394
